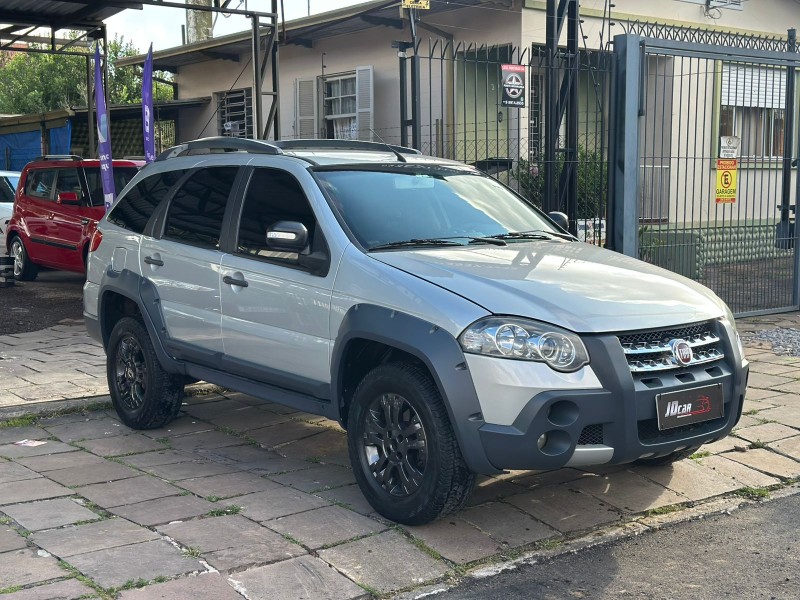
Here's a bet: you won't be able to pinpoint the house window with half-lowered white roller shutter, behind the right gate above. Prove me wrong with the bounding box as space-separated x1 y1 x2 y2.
719 64 786 159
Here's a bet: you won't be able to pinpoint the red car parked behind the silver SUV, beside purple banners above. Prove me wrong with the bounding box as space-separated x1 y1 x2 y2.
6 156 144 281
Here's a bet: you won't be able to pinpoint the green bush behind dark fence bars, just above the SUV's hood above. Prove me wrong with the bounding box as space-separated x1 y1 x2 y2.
512 145 608 219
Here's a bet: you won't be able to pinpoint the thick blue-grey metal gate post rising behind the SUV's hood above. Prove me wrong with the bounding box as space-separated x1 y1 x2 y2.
608 35 644 258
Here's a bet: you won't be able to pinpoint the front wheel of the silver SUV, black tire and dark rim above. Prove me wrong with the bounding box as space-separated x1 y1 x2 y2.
347 362 475 525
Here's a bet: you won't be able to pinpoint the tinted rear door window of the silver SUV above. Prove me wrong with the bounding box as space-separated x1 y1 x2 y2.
164 167 239 248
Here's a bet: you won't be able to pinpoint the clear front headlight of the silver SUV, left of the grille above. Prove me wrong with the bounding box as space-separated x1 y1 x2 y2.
458 317 589 372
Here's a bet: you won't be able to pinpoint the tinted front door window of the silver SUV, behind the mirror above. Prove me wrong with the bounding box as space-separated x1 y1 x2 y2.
236 168 316 262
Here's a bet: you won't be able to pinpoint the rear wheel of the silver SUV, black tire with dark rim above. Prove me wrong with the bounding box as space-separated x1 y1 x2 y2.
106 317 183 429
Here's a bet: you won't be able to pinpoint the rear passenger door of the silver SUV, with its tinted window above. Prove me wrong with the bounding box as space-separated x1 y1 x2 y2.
139 166 239 366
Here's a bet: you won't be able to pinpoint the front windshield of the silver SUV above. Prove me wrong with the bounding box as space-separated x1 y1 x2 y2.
315 164 560 249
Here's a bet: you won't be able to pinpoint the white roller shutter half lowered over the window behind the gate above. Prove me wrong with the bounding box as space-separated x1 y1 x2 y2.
722 64 786 108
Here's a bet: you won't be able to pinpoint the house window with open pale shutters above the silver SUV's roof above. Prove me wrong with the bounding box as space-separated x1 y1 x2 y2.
294 67 374 140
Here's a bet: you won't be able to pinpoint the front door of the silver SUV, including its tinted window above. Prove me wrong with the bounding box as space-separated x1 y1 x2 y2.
221 167 338 395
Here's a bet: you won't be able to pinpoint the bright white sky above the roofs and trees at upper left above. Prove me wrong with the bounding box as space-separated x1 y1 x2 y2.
106 0 376 53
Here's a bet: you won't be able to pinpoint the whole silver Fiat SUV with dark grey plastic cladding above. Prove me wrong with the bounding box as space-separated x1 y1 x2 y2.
84 138 748 524
